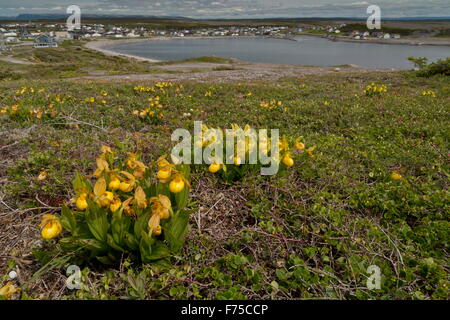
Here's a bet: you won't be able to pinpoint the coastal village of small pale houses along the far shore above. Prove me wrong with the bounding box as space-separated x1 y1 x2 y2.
0 22 400 52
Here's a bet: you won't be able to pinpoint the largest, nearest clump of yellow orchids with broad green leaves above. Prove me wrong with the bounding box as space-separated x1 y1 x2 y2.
41 146 190 264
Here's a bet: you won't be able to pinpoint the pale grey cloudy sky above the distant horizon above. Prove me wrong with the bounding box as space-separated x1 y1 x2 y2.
0 0 450 19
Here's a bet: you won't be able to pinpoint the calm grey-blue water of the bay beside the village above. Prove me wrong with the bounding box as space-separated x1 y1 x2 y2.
109 36 450 69
